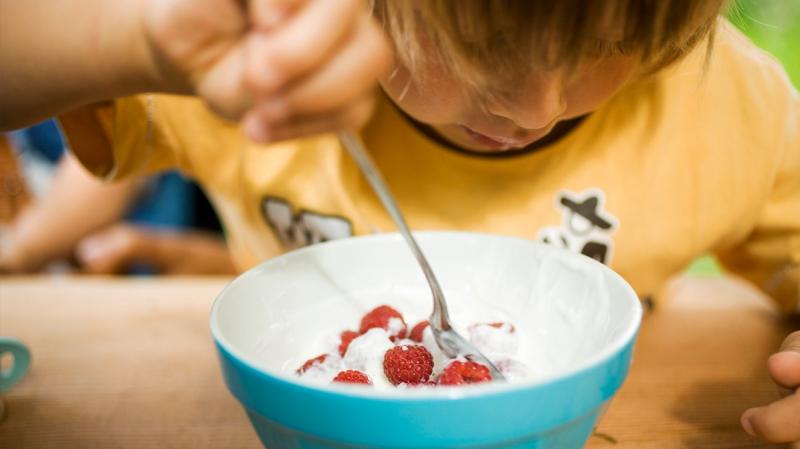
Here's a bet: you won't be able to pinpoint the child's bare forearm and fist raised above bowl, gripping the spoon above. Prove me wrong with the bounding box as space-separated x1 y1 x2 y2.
0 0 390 141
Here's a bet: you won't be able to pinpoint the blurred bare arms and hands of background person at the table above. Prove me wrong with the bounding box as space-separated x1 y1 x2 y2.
0 150 236 274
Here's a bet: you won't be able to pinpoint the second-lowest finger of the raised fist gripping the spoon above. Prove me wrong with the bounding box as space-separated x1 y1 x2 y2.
268 18 390 119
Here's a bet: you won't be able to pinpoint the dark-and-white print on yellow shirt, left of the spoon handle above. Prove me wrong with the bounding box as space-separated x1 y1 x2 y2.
261 196 353 249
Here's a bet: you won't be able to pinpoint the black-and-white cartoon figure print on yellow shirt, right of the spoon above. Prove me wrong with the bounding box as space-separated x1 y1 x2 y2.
538 189 618 265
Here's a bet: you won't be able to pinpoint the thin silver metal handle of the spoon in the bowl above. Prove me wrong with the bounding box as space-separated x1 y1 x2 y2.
339 131 450 331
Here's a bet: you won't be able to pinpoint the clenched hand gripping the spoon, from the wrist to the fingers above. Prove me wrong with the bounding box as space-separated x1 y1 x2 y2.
144 0 390 142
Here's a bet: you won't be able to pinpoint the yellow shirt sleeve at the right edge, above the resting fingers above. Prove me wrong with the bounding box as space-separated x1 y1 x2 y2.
718 74 800 313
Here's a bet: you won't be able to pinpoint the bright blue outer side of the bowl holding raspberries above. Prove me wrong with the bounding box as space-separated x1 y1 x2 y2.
212 328 635 449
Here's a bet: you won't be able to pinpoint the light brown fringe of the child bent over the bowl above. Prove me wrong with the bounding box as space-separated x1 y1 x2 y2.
370 0 725 91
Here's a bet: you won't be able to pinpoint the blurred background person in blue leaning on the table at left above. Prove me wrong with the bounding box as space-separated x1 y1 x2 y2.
0 120 235 274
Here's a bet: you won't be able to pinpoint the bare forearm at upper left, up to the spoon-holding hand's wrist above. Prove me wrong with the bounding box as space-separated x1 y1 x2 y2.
0 0 166 129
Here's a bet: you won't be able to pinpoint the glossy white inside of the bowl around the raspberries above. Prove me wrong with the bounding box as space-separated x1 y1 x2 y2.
211 233 641 386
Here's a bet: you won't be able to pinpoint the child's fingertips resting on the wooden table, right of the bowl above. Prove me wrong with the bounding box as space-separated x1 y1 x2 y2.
742 331 800 443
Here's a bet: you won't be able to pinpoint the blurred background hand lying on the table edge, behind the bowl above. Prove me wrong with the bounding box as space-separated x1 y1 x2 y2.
75 224 236 274
